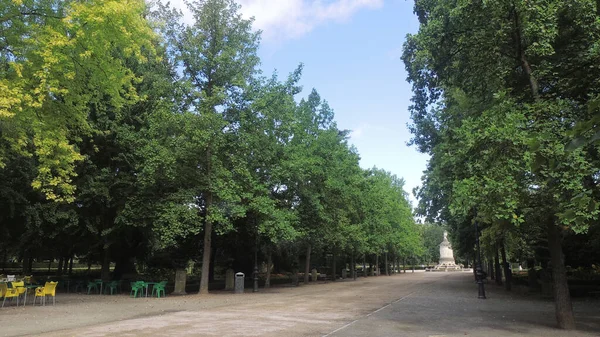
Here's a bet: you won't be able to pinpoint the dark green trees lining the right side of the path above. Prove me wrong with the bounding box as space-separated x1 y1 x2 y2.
403 0 600 329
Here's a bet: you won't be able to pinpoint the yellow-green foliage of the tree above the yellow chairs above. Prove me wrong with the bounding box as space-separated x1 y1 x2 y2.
0 0 153 201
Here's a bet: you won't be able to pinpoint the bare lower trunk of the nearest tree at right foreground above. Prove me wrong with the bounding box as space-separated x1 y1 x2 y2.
547 224 575 330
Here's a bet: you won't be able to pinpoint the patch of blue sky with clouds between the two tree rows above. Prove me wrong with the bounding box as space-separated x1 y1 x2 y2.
164 0 428 206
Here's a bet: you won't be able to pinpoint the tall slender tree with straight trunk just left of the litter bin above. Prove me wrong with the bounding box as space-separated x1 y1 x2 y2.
152 0 259 294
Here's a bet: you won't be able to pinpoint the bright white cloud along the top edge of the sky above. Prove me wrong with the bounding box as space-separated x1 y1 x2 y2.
163 0 384 42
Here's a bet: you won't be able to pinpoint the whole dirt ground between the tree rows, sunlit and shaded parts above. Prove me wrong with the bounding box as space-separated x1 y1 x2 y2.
0 272 600 337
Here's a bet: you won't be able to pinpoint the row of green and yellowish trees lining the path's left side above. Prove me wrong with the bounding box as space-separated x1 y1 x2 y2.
0 0 422 293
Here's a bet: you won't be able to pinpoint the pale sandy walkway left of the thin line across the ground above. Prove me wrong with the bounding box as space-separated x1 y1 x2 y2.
0 273 422 337
